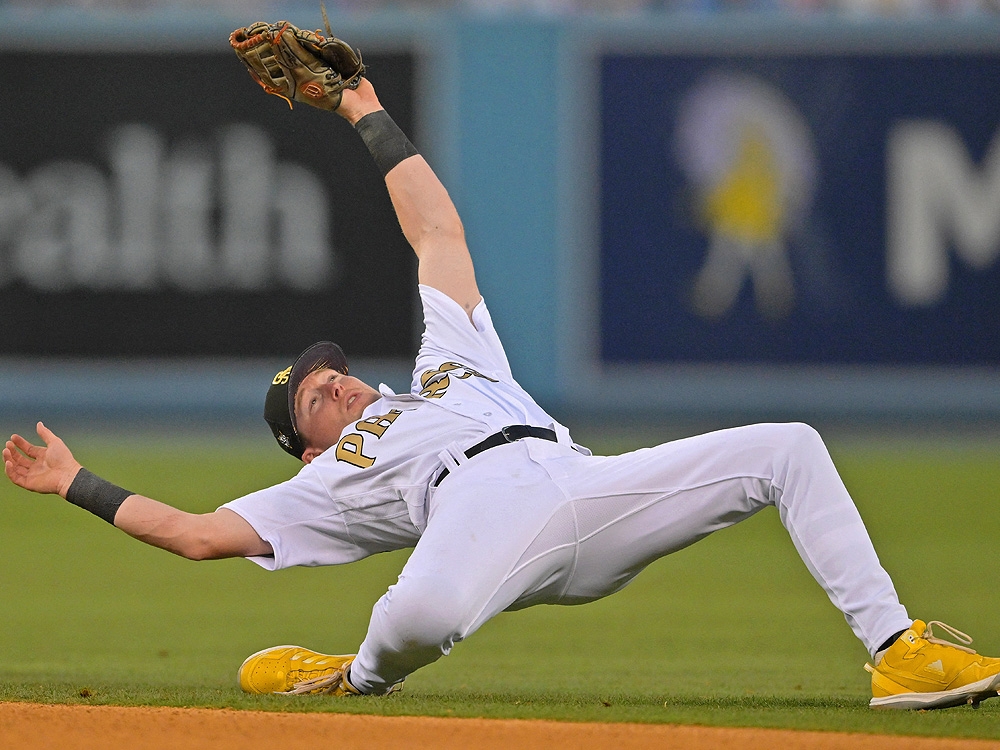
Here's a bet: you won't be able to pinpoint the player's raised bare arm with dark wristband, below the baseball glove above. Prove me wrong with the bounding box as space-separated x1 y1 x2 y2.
337 79 482 317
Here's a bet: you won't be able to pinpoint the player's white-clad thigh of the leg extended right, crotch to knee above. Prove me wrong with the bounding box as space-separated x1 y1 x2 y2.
566 425 809 600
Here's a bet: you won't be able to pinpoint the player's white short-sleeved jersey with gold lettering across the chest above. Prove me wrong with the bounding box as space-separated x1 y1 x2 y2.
222 285 572 570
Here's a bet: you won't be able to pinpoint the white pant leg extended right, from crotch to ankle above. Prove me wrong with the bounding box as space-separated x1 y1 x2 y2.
550 424 911 653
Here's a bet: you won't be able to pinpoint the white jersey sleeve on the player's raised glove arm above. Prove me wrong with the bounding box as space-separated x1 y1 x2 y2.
417 284 512 380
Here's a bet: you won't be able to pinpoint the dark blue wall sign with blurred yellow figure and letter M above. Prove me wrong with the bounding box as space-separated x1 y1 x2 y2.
600 52 1000 365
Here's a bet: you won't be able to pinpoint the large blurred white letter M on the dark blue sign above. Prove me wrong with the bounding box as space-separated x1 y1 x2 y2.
886 120 1000 306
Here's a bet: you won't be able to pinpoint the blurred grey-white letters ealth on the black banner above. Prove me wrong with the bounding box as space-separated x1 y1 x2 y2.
0 124 336 291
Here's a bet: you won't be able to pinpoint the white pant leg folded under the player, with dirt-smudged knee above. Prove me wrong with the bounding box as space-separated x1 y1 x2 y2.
351 443 576 693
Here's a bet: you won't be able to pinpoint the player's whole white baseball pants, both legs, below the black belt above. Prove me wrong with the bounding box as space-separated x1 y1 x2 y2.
351 424 911 693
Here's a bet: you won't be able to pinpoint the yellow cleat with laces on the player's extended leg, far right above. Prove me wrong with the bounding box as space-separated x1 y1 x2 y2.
865 620 1000 709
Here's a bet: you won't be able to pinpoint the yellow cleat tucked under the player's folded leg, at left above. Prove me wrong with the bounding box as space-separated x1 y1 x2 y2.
239 646 361 696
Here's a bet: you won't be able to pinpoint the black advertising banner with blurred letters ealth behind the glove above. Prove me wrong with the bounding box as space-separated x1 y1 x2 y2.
0 47 415 357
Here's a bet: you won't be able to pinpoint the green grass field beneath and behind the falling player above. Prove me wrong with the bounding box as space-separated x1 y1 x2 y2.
0 423 1000 738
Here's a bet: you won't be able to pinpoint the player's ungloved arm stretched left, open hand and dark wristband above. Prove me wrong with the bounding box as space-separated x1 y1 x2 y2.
3 422 272 560
